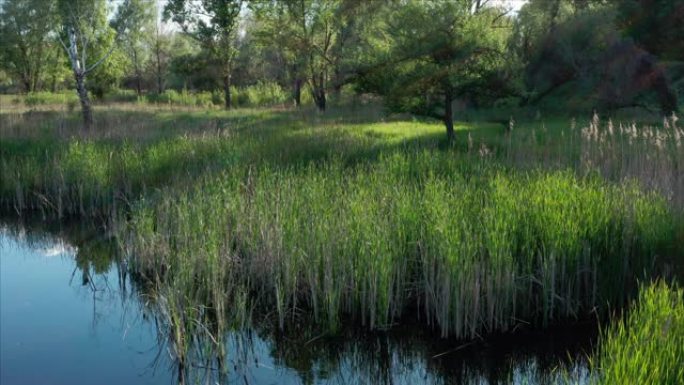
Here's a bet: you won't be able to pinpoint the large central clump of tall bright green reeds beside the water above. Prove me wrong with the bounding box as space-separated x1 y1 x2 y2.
125 152 675 337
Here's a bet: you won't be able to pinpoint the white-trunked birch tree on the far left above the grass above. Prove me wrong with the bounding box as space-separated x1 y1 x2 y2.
58 0 128 130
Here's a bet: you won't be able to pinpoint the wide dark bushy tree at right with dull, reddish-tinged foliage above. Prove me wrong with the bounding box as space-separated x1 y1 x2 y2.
513 0 677 114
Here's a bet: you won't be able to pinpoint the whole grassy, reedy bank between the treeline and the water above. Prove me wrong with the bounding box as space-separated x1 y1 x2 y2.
0 106 684 337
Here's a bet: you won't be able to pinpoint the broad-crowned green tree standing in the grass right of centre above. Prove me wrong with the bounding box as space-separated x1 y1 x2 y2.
361 1 509 140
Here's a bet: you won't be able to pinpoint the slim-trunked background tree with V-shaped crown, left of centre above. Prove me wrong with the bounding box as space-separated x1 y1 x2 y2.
164 0 243 109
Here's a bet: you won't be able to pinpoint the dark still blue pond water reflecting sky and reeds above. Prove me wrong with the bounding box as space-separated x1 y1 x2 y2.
0 226 596 385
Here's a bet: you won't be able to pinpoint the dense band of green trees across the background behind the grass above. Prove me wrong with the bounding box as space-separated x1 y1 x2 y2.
0 0 684 137
